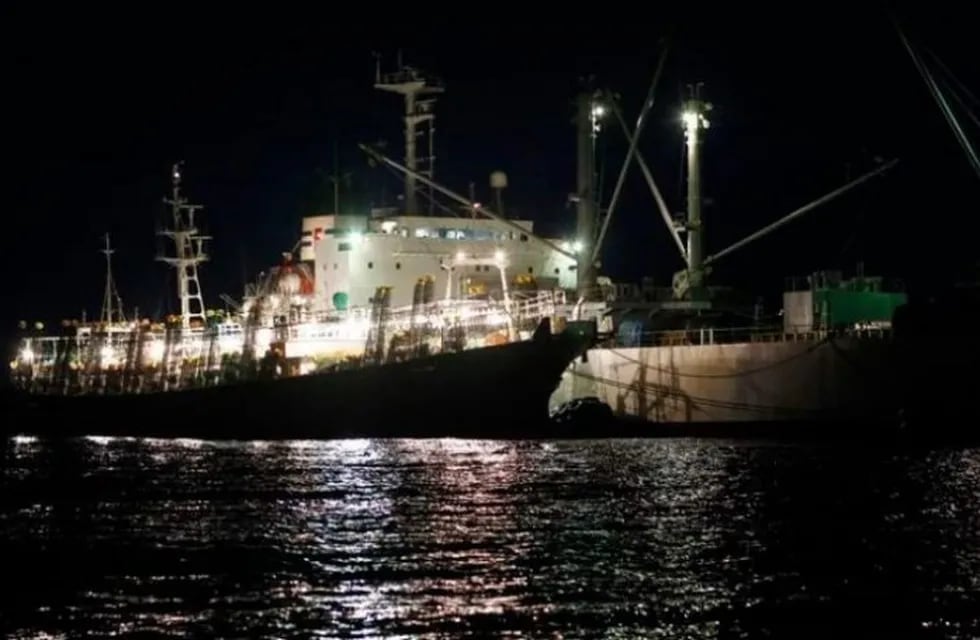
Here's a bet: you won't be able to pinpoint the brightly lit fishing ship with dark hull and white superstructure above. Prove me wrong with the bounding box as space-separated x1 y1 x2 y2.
4 57 596 439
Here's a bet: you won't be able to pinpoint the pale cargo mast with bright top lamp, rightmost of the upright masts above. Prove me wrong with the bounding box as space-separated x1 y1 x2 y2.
682 82 711 300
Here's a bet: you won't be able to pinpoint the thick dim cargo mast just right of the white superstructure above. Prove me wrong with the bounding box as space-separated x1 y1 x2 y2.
574 88 604 298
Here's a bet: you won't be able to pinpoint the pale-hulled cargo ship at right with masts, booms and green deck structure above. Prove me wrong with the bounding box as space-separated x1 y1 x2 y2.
552 47 907 435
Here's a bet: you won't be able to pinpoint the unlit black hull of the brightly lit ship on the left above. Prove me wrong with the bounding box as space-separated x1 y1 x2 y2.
4 324 588 440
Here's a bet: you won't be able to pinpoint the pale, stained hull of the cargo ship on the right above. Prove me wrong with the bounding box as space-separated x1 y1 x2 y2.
552 336 895 423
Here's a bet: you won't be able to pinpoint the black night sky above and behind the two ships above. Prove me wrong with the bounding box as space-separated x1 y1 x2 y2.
2 4 980 336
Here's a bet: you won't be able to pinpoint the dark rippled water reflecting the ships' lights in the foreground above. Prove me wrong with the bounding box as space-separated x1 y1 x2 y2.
0 440 980 638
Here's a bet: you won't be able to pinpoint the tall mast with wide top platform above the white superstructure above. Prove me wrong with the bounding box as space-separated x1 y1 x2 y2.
374 53 445 215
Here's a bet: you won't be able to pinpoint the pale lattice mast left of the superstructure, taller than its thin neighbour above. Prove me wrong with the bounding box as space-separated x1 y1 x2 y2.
157 163 211 330
